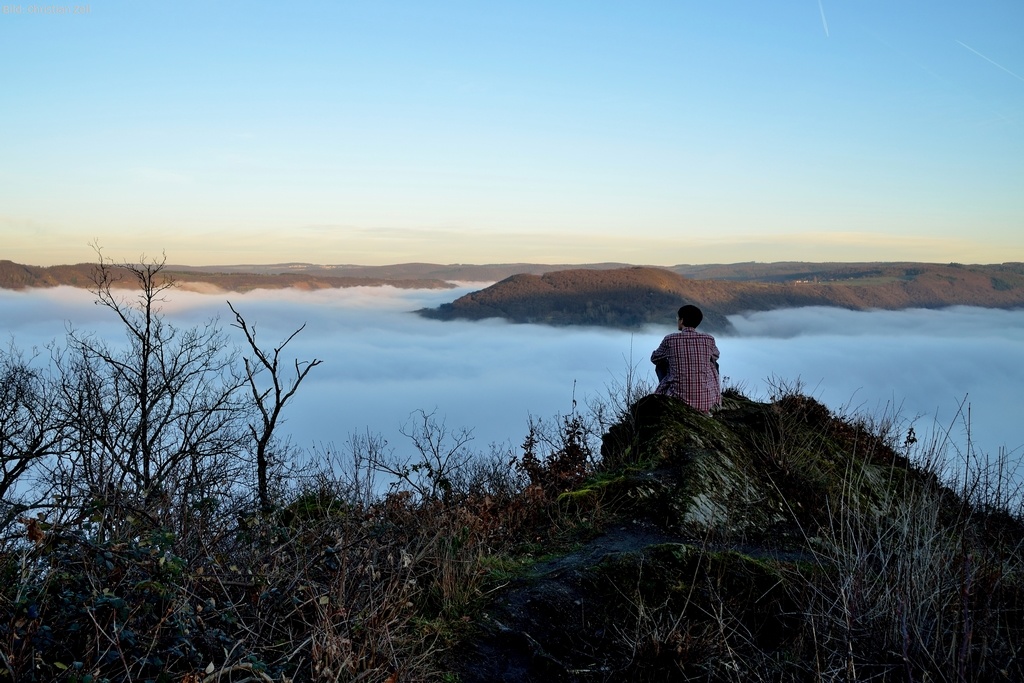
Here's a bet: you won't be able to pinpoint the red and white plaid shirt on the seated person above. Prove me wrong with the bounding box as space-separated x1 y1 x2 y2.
650 328 722 413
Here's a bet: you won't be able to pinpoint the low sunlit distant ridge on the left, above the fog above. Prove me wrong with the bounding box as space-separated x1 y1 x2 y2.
0 260 454 292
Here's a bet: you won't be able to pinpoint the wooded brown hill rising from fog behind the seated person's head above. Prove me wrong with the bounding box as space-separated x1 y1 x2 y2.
419 263 1024 332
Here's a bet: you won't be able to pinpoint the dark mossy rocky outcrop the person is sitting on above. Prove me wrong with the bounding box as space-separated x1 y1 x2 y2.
453 394 1024 683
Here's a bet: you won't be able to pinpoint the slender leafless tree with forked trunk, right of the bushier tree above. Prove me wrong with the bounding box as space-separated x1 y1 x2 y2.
227 301 322 511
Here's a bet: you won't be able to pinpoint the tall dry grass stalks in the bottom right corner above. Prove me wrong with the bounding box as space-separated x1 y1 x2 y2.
804 440 1024 681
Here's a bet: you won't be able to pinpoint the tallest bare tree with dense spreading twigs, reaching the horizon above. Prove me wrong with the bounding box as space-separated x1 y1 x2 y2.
55 248 247 532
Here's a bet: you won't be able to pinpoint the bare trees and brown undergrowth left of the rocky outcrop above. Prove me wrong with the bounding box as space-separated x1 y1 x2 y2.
0 252 591 683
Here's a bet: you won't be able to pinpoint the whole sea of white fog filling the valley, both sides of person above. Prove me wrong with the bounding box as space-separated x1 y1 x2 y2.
6 284 1024 471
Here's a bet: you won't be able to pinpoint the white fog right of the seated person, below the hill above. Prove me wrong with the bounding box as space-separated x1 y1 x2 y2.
720 307 1024 457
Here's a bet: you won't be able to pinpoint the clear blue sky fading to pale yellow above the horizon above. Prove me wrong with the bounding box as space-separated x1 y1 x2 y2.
0 0 1024 265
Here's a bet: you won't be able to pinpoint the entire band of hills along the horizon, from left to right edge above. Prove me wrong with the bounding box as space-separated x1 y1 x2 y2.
0 260 1024 330
